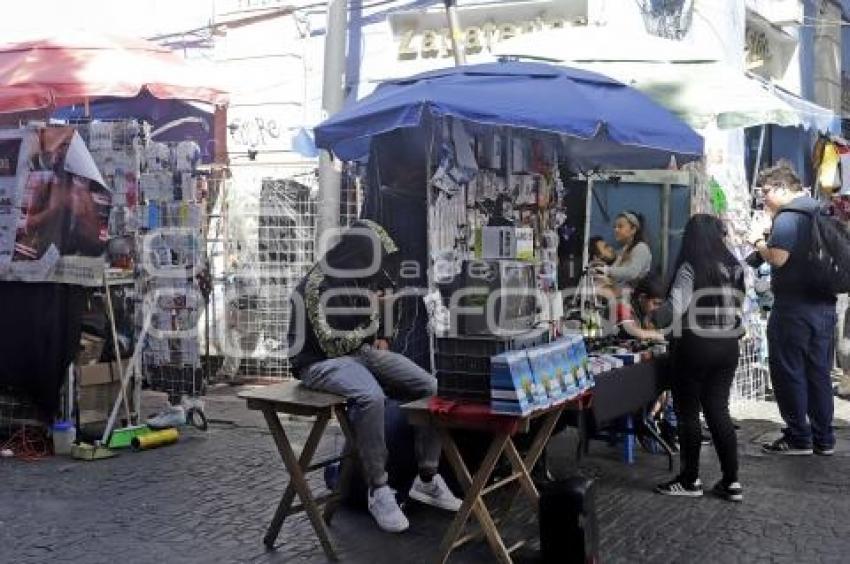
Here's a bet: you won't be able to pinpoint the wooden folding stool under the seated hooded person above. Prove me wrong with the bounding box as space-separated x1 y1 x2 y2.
239 381 357 560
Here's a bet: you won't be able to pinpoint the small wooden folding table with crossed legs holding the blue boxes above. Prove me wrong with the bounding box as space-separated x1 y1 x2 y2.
402 396 586 564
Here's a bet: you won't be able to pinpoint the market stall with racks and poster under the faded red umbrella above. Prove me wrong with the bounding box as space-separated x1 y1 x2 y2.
0 31 227 450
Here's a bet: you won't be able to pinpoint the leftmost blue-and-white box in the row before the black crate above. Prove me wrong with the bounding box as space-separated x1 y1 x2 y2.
490 351 539 415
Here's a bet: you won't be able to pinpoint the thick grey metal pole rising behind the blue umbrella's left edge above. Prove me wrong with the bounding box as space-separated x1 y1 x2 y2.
316 0 348 255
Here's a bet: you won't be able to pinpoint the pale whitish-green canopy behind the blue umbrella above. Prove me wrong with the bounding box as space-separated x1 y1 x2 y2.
494 27 837 134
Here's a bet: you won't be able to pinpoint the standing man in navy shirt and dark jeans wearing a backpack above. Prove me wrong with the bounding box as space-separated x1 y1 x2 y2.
750 161 836 456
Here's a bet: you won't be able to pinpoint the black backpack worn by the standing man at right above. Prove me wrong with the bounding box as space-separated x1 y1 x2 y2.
783 207 850 295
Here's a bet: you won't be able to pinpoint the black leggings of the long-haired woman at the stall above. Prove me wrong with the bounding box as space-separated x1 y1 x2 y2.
671 335 739 484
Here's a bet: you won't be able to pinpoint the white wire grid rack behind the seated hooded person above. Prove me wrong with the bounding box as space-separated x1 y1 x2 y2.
219 167 360 383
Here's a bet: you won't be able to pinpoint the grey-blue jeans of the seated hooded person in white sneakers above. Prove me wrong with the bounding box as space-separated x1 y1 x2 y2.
300 345 441 487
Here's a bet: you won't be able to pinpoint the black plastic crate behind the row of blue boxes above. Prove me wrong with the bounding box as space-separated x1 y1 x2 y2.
434 328 549 402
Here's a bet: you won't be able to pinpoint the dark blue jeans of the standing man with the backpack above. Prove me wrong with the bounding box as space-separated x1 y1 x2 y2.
767 304 837 448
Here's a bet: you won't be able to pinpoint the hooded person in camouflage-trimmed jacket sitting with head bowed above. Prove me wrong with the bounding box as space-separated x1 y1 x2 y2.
288 220 461 532
